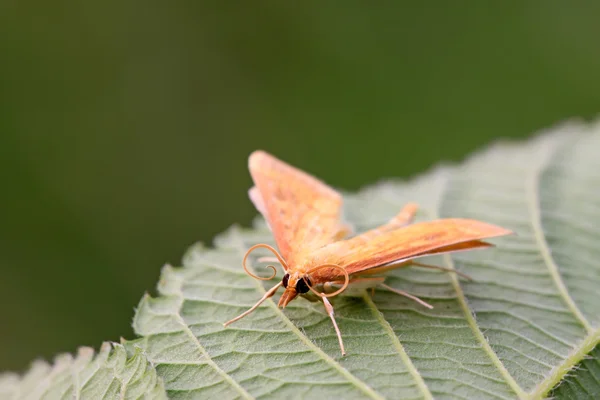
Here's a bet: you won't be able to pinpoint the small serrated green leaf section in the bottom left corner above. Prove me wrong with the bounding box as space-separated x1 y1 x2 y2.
0 343 167 400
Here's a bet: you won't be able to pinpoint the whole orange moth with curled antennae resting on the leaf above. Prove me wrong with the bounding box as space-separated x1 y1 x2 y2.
224 150 512 355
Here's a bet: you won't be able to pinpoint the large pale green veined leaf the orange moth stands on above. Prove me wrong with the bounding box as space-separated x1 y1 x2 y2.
134 123 600 399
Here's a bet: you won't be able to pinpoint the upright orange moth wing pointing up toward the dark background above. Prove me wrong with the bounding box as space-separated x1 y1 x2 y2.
248 150 344 263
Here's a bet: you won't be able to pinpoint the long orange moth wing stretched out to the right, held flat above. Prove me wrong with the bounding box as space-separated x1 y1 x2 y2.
313 218 512 274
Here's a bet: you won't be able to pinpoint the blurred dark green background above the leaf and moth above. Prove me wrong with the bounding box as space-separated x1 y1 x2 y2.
0 0 600 370
